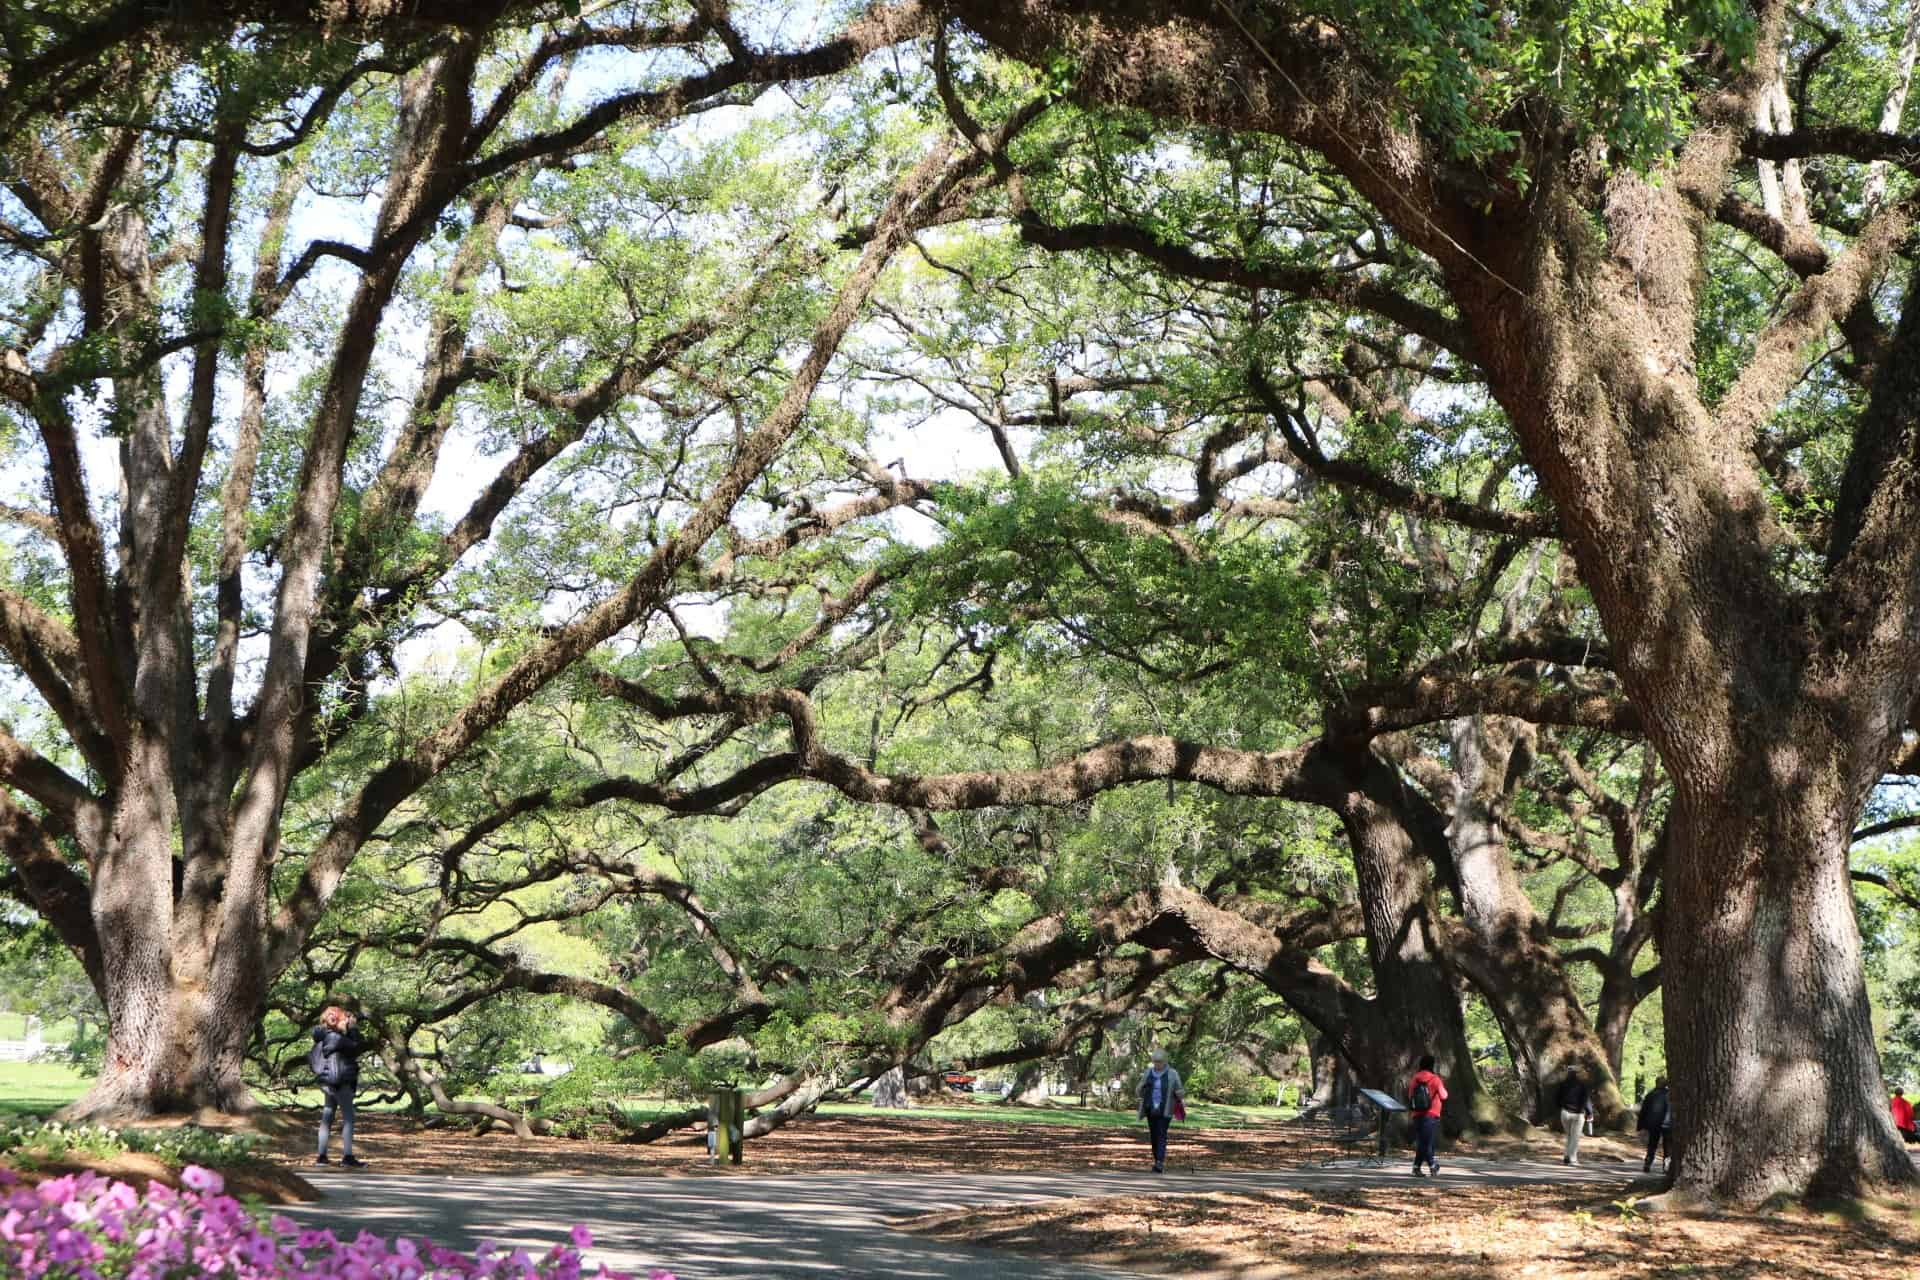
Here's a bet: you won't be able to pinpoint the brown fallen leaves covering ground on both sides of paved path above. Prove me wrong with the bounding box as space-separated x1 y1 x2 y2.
255 1109 1920 1280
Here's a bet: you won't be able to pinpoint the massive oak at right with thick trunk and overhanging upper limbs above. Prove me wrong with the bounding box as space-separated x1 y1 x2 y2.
933 0 1920 1201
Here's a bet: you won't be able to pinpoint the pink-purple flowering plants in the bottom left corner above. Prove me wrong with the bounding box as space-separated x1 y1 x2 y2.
0 1165 674 1280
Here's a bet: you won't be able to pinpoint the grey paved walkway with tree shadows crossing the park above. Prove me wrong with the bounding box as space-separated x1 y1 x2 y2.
288 1159 1640 1280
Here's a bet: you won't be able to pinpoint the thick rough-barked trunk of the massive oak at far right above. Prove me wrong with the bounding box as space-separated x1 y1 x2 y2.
1469 182 1920 1203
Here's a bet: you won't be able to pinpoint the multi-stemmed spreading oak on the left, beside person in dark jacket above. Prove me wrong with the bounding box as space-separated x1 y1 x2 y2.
0 6 1046 1115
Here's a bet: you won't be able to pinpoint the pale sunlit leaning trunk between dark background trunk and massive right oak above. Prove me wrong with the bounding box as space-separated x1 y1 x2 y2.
1448 716 1626 1125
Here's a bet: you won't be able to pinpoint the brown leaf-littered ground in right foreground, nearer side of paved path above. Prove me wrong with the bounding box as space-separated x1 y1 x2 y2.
904 1176 1920 1280
